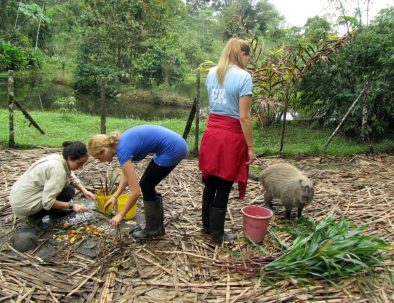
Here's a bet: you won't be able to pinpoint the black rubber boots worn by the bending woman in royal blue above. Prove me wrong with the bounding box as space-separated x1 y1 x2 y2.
133 198 165 240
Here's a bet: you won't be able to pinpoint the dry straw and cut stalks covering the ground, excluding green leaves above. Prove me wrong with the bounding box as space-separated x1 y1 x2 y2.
0 149 394 303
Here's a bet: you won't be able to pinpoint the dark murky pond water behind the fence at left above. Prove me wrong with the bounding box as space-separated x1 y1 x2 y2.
0 77 206 120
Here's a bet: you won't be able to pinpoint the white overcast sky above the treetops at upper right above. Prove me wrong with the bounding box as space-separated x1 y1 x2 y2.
269 0 394 26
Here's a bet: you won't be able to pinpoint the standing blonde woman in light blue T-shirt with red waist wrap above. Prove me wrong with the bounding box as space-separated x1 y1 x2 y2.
199 38 256 244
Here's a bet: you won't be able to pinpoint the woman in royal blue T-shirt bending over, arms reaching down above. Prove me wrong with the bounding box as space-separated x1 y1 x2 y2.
88 125 188 239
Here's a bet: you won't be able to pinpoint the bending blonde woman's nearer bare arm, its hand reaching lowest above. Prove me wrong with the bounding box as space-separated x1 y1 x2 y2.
110 161 141 226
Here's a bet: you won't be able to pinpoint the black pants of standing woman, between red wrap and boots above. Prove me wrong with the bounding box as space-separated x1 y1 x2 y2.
202 175 234 208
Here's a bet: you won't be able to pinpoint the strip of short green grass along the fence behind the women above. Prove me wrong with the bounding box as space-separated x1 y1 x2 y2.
0 109 394 156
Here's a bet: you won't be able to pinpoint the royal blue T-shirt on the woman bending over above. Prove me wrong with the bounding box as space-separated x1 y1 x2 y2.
116 125 188 167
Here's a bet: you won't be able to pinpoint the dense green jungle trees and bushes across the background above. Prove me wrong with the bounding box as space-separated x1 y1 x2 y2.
0 0 394 152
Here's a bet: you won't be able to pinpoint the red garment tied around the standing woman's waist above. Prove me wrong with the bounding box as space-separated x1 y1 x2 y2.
199 114 249 199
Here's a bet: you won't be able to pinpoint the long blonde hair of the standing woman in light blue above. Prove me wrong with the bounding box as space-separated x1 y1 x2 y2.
216 38 250 84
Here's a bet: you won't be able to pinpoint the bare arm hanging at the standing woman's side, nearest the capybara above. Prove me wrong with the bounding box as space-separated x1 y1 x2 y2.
239 96 256 164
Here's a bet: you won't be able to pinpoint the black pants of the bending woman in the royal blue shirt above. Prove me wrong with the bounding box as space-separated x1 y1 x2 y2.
140 160 176 201
